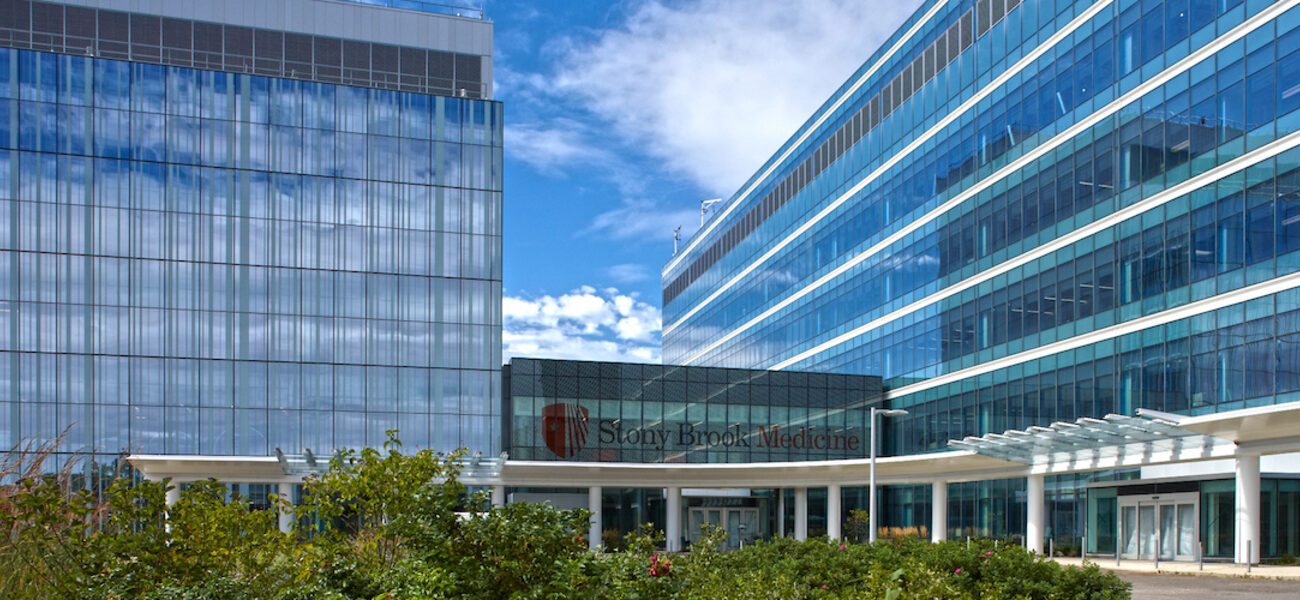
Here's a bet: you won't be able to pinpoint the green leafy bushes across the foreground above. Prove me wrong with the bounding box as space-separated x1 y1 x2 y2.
0 436 1128 600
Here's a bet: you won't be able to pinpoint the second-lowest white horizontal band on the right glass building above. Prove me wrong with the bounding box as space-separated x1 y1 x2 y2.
774 124 1300 369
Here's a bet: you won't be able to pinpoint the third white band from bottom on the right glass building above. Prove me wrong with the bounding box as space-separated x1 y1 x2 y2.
664 0 1300 355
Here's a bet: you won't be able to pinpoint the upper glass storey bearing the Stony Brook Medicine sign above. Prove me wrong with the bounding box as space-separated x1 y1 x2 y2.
502 357 881 462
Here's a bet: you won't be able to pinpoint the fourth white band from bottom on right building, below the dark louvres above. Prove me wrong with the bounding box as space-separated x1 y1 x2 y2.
663 0 1113 332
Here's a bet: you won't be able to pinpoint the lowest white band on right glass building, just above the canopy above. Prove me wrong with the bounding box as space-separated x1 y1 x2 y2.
885 268 1300 399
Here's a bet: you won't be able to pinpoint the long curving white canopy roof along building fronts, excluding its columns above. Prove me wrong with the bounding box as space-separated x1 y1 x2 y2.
127 401 1300 488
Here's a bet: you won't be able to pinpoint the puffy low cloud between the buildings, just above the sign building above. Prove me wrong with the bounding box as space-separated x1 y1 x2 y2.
502 286 662 362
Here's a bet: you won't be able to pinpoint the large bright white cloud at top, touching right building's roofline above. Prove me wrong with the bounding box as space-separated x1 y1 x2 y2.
545 0 918 197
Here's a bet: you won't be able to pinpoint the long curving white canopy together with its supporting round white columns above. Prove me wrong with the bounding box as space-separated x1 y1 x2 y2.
129 401 1300 562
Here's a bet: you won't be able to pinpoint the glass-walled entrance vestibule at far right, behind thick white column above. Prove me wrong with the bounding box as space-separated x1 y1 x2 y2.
1087 475 1300 561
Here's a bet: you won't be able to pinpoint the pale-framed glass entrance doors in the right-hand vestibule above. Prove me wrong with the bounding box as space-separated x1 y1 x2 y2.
1119 494 1200 561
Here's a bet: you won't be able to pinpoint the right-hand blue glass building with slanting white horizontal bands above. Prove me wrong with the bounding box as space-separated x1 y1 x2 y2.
663 0 1300 556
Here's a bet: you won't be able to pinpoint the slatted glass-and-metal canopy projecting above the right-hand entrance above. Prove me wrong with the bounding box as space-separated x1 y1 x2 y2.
948 410 1235 473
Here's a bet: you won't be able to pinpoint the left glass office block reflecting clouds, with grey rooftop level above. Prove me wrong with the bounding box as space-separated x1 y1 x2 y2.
0 0 502 467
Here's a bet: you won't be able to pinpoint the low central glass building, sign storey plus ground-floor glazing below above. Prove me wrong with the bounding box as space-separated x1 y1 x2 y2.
502 357 881 547
